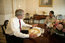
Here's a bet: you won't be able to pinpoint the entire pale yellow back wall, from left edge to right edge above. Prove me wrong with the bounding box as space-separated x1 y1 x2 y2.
0 0 65 24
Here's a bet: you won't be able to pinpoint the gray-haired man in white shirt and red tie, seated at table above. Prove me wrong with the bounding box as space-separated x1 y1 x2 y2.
5 9 37 43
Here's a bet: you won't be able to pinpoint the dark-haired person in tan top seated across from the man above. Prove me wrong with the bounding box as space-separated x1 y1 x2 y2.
44 11 56 33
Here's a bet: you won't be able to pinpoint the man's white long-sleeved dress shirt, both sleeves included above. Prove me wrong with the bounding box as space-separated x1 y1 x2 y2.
5 17 32 38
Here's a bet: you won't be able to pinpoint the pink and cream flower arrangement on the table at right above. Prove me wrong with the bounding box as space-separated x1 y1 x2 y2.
47 19 65 36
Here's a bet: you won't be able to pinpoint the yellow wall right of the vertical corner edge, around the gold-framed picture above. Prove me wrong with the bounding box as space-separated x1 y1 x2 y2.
9 0 65 16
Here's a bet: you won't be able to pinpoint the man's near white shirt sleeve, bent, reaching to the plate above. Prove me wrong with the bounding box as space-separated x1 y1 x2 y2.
11 21 29 38
